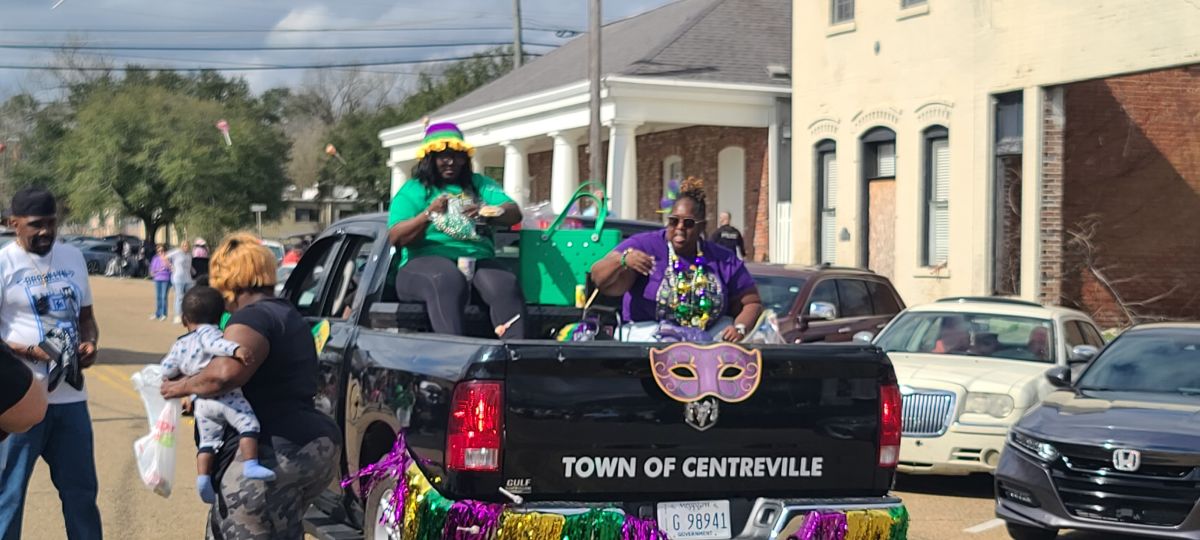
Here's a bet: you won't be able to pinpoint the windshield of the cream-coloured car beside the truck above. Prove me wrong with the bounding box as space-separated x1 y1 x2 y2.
876 312 1055 362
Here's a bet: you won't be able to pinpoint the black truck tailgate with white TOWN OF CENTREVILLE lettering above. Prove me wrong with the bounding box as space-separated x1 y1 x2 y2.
502 342 892 500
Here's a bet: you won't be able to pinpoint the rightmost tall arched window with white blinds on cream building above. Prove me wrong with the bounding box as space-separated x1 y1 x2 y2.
922 126 950 266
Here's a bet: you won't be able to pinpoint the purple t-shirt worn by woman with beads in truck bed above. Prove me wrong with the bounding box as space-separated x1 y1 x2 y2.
614 230 754 323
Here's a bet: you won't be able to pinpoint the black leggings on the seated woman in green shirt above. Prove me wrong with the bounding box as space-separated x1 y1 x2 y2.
396 256 526 340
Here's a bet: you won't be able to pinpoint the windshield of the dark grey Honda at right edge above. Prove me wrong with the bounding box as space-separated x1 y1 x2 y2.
1079 331 1200 395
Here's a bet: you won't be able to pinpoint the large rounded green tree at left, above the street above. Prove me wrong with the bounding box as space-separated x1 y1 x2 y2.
52 84 289 242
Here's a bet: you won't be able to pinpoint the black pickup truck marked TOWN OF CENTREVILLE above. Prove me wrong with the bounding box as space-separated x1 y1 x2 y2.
290 215 901 539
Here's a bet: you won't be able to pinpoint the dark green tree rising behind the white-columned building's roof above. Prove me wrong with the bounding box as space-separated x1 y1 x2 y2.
319 48 512 209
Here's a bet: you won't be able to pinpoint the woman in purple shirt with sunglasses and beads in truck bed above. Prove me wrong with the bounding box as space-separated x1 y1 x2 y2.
592 178 762 341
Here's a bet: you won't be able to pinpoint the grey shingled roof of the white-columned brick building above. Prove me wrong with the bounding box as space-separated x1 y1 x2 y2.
433 0 792 116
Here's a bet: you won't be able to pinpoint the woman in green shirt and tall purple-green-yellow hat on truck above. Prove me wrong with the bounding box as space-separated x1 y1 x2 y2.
388 124 524 338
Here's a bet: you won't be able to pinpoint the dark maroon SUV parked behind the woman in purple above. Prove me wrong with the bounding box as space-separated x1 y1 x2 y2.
746 264 905 343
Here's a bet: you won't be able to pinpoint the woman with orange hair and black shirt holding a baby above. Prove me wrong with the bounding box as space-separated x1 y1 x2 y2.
162 233 342 540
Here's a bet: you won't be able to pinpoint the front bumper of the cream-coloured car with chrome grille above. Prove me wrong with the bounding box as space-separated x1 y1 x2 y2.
896 424 1008 475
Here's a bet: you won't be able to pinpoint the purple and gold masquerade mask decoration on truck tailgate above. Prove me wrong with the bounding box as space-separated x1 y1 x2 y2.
650 343 762 403
